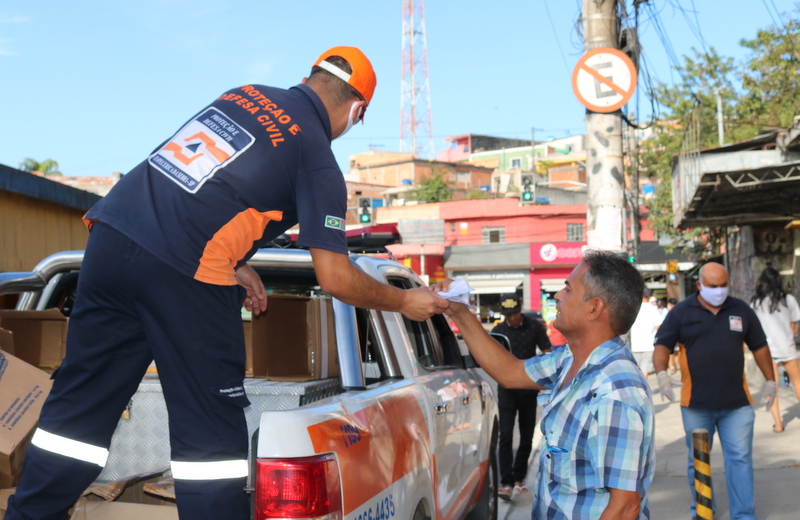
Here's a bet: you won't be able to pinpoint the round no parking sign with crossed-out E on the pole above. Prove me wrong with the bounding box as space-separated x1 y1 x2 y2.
572 47 636 113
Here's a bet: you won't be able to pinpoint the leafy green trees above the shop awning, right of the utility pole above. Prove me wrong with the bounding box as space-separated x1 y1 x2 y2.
639 7 800 255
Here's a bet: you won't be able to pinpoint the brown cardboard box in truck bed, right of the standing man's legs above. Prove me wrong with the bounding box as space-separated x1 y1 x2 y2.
243 294 339 381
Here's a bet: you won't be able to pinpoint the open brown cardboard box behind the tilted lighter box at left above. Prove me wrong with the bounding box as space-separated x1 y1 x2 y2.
0 309 67 368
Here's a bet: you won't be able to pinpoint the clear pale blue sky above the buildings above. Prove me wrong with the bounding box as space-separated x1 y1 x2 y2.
0 0 796 176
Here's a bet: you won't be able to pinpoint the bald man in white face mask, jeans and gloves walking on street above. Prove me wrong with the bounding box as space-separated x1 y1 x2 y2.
653 262 776 520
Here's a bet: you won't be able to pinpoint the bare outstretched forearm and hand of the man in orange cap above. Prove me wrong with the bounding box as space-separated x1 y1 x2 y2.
311 248 448 321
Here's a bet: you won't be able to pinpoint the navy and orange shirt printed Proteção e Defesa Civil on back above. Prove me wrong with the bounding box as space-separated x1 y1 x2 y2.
85 85 347 285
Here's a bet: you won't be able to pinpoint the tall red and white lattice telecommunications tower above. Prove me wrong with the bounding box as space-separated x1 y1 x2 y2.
400 0 434 159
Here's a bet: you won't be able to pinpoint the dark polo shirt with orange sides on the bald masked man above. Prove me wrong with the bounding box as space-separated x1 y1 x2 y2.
654 293 767 410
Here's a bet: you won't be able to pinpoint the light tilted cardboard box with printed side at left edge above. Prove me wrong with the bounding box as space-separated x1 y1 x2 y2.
0 351 52 488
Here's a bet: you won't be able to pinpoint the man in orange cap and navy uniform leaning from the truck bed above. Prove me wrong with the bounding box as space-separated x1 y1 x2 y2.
5 47 448 520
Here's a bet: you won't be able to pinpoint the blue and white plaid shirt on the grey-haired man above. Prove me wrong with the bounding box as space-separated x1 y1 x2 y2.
525 338 655 520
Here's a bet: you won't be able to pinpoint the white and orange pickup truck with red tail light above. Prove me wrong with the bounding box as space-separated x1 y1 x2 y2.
0 248 498 520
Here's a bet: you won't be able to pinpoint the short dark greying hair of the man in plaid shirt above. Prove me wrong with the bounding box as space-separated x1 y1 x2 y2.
582 249 644 334
